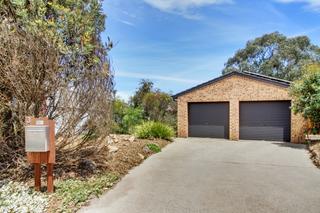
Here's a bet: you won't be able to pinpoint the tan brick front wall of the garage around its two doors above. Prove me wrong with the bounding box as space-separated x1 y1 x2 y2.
177 75 305 143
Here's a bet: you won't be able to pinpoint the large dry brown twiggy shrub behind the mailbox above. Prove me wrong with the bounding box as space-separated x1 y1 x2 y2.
0 21 113 178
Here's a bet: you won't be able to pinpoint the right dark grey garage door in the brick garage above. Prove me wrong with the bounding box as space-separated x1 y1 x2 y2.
240 101 291 142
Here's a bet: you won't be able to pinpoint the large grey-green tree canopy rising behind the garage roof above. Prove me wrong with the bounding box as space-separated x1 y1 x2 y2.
223 32 320 81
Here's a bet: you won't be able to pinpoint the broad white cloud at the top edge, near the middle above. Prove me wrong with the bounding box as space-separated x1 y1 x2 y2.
144 0 233 19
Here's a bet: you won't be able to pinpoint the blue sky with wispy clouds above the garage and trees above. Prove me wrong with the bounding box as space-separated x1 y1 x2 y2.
102 0 320 100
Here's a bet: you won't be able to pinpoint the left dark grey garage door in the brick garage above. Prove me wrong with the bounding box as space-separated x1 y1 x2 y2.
188 102 229 138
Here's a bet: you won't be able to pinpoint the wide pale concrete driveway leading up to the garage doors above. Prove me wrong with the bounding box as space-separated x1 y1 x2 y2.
81 138 320 213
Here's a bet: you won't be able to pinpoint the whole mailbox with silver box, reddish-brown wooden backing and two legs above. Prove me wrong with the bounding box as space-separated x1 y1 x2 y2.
25 117 56 192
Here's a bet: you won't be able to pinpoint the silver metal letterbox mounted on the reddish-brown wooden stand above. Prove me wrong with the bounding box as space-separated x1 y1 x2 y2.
25 125 50 152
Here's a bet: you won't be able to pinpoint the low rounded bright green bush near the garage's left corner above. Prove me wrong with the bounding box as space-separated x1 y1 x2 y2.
134 121 175 140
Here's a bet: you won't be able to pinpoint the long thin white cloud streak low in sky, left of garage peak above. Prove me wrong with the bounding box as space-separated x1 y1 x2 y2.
116 71 200 83
